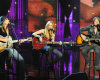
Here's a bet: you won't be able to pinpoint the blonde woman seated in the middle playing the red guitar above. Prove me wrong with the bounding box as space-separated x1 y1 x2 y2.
32 21 63 64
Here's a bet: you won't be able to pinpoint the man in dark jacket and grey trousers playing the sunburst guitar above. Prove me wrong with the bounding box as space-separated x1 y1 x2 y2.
80 17 100 70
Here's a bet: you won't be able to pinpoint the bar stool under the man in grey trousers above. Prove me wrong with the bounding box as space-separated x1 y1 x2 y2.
84 49 95 80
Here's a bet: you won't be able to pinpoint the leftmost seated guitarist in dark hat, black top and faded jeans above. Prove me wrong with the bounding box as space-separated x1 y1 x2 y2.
0 16 24 80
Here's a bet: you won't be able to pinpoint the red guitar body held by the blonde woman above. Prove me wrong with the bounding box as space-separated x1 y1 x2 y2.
32 37 49 50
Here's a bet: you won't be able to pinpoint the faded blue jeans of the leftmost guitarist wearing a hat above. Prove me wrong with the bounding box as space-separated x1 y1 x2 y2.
0 48 24 80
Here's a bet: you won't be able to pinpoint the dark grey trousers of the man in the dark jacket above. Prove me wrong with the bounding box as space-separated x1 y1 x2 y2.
82 43 100 66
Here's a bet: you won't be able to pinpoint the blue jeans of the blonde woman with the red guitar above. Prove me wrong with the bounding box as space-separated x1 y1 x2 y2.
41 46 63 64
